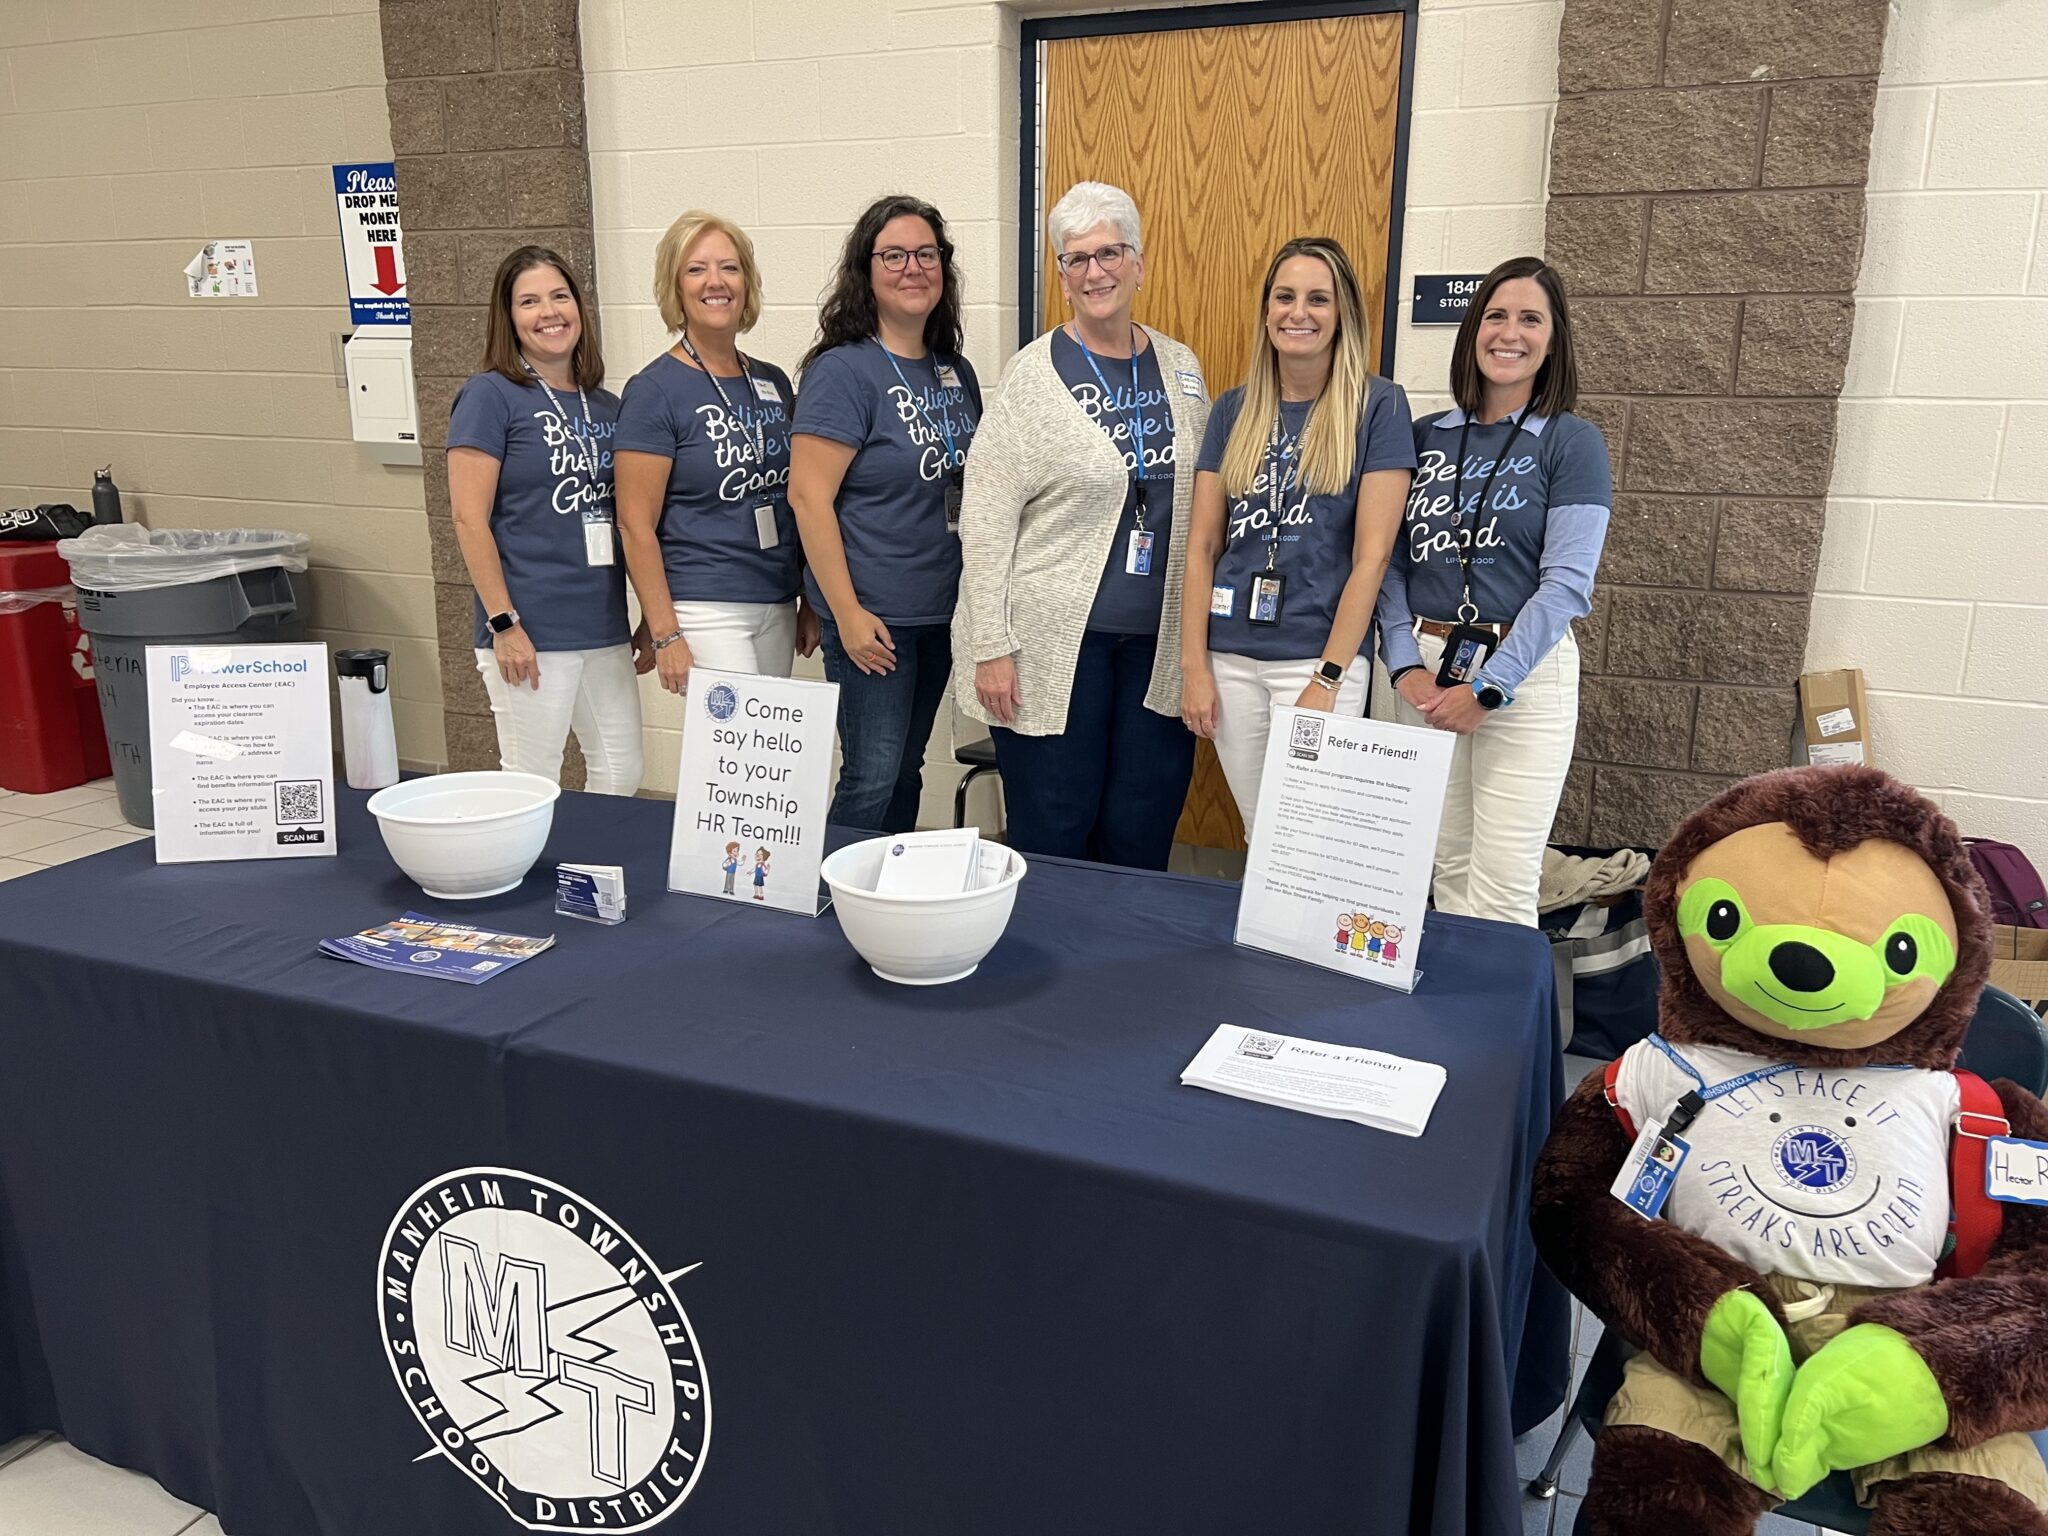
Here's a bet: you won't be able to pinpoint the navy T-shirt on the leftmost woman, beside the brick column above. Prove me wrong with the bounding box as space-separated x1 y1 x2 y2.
449 373 631 651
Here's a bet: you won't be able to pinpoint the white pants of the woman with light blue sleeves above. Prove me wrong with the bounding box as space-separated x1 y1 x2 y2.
1395 631 1579 928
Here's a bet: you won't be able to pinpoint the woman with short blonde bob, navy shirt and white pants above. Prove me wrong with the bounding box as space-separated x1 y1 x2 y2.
618 209 817 708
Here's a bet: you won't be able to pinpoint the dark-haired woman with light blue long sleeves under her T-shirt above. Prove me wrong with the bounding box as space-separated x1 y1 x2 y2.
1378 256 1614 926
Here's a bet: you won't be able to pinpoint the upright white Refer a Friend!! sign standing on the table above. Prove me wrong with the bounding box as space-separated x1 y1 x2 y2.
1237 707 1456 991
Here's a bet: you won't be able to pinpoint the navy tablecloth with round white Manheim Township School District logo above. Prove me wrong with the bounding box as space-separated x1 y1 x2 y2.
0 795 1565 1536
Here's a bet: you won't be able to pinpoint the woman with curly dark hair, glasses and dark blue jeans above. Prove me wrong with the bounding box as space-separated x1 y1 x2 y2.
788 197 981 831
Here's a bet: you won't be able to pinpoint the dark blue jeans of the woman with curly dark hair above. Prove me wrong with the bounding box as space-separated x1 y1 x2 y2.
823 618 952 831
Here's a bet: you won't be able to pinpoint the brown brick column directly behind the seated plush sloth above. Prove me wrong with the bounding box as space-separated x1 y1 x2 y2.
1546 0 1886 846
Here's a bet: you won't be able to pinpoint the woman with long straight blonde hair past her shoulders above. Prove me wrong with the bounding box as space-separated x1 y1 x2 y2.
1180 238 1415 836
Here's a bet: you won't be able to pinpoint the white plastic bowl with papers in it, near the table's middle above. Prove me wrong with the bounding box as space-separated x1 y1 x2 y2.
819 838 1028 987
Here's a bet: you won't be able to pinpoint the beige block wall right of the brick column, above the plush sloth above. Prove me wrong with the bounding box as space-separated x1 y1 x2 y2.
1806 0 2048 862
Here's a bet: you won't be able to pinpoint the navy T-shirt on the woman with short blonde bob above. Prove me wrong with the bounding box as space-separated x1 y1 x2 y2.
616 352 803 602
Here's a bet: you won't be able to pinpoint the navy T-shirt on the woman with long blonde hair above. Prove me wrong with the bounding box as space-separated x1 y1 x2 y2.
1196 377 1415 662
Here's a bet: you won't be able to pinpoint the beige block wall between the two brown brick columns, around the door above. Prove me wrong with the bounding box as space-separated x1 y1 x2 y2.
582 0 1561 823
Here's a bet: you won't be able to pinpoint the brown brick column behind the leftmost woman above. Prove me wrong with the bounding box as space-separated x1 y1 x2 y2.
379 0 598 788
